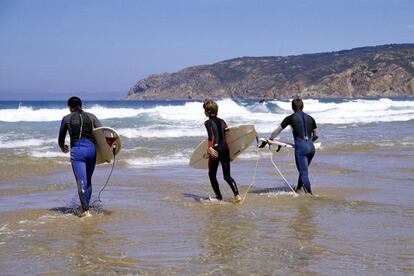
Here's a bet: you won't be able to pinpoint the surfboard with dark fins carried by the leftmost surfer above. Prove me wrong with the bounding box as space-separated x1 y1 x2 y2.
93 127 122 165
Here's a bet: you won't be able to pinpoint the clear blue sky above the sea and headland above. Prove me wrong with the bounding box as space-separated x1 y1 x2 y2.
0 0 414 100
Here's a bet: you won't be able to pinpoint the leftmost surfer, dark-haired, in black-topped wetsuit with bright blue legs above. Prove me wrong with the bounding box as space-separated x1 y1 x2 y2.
58 97 102 217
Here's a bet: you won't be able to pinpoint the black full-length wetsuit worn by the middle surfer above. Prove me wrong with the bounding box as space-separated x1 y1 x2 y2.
204 116 239 200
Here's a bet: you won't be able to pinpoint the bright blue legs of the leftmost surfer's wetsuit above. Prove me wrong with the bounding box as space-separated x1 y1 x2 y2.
71 139 96 211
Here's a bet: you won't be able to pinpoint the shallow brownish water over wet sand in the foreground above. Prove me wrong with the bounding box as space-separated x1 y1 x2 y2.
0 149 414 275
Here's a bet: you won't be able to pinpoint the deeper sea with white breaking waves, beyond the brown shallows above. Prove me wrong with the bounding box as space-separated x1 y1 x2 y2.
0 99 414 175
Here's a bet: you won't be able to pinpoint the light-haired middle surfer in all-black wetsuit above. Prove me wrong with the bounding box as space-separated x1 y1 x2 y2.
203 100 241 203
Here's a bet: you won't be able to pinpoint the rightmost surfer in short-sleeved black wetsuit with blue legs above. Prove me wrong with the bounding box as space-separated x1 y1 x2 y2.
270 99 318 194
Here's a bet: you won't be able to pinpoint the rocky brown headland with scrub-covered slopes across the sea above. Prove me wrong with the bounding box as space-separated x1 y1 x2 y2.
125 44 414 100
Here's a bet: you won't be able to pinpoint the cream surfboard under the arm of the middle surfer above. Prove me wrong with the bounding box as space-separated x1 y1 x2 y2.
190 125 257 169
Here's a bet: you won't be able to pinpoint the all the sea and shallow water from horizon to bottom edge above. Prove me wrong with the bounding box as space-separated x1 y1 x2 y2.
0 98 414 275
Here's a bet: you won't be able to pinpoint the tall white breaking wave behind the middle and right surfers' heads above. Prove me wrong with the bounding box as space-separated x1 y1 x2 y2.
146 99 414 126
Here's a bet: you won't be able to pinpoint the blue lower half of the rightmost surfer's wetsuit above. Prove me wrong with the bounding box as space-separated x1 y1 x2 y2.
295 139 315 194
